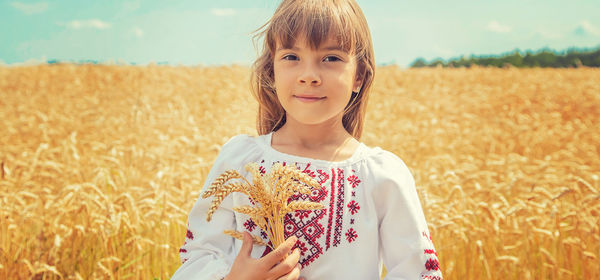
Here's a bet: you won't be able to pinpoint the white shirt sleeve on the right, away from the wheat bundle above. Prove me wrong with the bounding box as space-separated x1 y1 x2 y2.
374 152 442 280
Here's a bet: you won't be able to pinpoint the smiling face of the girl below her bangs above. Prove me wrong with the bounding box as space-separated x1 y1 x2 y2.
273 36 362 127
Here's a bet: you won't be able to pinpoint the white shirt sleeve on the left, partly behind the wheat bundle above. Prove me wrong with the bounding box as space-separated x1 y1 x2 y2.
171 135 254 280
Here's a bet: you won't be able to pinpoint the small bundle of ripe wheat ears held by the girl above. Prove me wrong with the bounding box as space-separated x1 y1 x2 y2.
202 163 323 249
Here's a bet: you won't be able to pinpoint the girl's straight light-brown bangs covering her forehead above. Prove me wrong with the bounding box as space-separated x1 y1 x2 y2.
265 0 360 54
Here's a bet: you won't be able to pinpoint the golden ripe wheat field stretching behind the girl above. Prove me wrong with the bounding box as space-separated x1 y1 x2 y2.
0 64 600 280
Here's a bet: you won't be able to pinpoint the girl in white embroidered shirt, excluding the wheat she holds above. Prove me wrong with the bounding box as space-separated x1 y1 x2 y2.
173 0 442 280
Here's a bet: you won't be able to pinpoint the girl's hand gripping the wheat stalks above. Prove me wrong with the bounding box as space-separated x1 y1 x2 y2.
224 232 305 280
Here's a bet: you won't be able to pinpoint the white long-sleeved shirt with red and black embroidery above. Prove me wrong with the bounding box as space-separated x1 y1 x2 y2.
172 133 442 280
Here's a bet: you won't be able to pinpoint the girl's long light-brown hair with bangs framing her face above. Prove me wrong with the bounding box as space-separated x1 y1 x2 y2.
251 0 375 139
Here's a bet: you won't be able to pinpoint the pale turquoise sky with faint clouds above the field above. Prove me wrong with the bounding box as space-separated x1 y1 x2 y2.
0 0 600 67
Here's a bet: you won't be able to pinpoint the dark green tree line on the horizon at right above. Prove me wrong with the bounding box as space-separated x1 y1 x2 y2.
410 48 600 68
